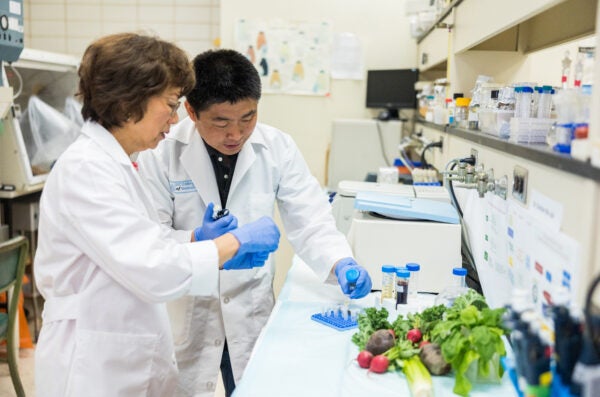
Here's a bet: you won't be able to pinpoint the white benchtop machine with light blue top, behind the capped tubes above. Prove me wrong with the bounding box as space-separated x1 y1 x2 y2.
333 181 462 293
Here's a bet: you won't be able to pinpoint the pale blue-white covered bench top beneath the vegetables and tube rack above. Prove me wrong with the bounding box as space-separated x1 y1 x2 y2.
234 257 516 397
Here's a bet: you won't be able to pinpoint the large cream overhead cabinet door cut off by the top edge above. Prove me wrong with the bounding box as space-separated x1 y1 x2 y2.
454 0 565 53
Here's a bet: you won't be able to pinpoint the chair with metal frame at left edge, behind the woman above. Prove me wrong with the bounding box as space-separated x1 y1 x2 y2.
0 236 29 397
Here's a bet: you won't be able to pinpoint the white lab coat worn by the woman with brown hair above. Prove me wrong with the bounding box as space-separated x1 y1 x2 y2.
35 123 219 397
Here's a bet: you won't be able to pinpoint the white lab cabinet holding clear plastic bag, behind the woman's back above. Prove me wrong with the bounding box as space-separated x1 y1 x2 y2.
0 49 79 192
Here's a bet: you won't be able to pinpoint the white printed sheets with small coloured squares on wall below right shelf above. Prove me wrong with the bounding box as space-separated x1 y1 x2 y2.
465 190 580 330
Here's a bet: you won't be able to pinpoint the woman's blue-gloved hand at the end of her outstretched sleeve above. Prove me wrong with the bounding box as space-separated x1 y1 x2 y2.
223 216 280 270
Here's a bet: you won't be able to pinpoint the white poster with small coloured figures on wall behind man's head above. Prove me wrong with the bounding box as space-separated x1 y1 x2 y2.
235 19 333 96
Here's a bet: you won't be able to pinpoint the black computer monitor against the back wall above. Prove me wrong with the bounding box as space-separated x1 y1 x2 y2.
367 69 419 120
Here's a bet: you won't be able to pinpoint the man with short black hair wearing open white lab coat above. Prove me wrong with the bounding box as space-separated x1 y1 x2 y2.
138 50 371 396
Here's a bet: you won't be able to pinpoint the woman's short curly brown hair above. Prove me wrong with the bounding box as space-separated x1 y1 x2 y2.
78 33 195 130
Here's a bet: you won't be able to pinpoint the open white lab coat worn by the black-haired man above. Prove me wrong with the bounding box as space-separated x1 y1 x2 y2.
138 118 352 396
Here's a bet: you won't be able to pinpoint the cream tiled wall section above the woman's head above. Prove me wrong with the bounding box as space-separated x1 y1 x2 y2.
23 0 220 57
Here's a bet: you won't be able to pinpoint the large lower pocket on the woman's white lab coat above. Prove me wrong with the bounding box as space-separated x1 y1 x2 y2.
67 329 159 397
